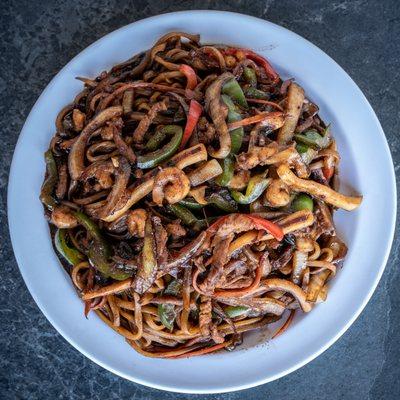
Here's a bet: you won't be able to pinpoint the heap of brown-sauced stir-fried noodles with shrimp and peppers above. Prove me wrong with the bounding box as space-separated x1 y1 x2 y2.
40 32 362 358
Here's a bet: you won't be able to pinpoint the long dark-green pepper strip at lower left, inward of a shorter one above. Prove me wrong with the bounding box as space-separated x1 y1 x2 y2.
74 211 133 281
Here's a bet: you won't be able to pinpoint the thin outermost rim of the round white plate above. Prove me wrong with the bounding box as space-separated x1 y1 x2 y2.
7 9 397 394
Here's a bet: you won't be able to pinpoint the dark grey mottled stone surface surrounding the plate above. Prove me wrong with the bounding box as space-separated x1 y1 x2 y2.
0 0 400 400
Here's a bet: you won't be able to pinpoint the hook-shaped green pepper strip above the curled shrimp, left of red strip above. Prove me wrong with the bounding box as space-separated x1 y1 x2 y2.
137 125 183 169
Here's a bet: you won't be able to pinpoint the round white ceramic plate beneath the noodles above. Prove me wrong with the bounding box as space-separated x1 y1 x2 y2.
8 11 396 393
